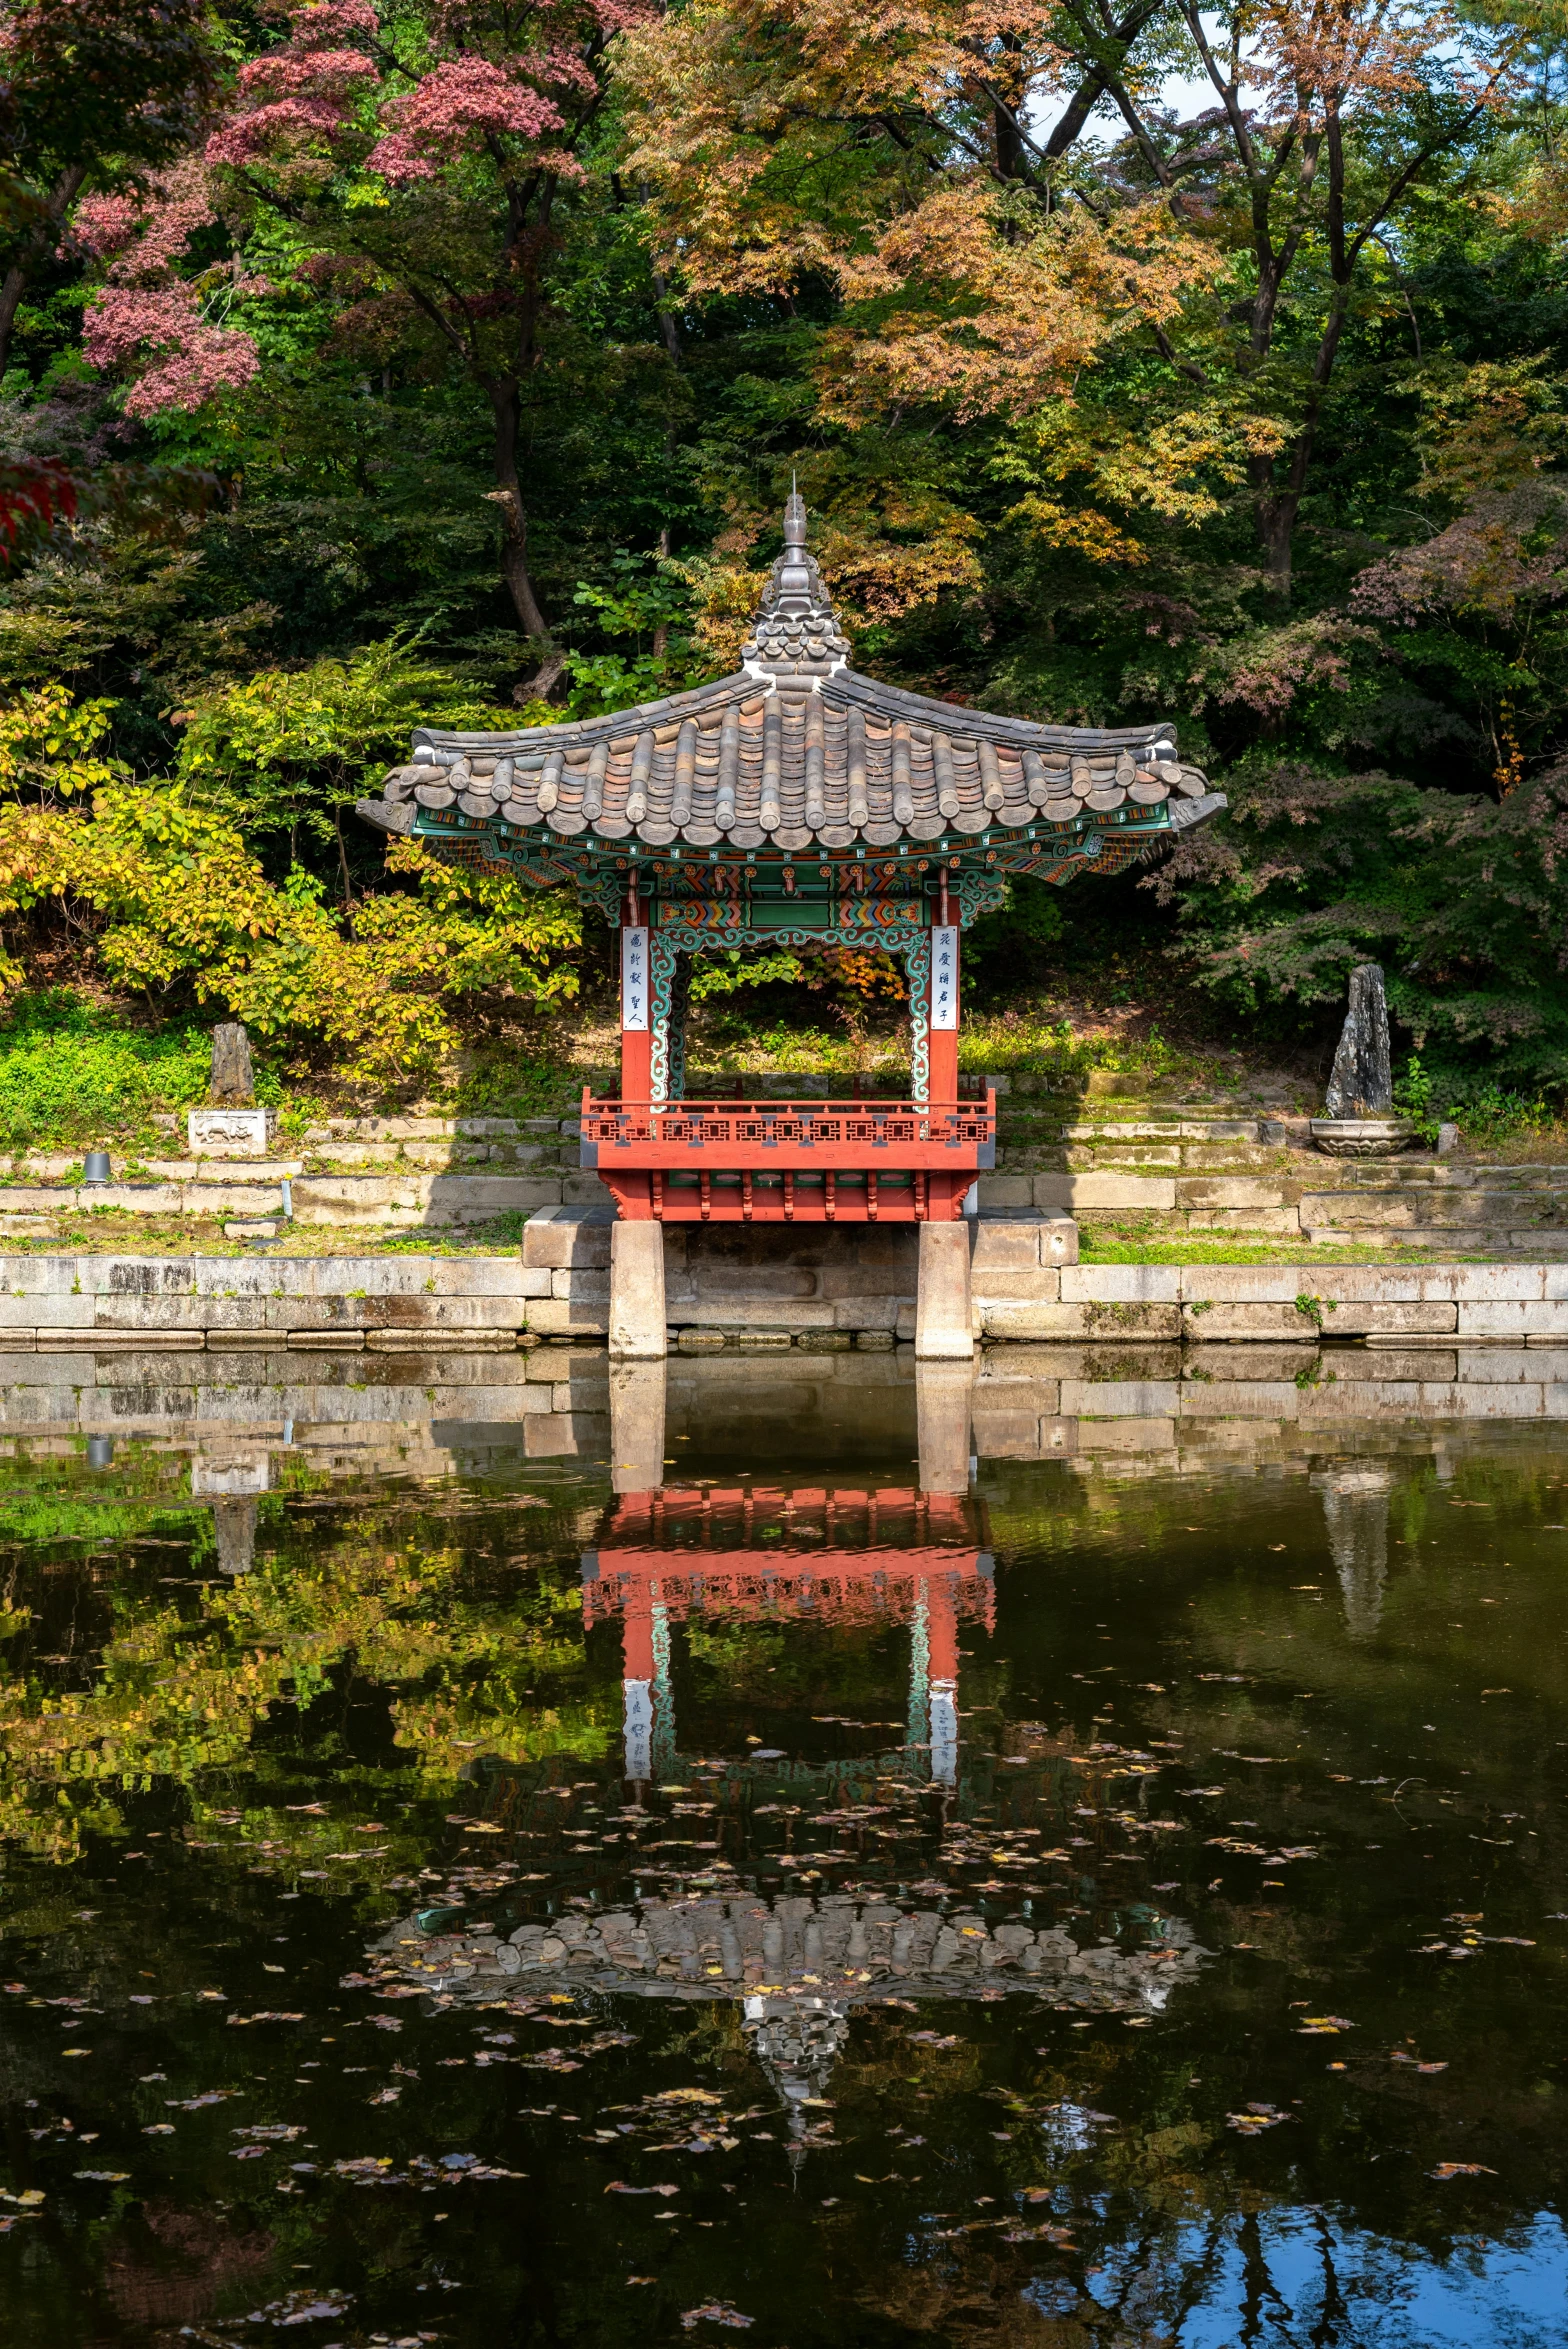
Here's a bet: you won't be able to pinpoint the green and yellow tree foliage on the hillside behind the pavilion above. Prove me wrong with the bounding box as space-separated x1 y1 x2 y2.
0 0 1568 1108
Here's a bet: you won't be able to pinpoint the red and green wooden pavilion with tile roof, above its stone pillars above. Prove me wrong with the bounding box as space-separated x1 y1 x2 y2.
359 498 1225 1221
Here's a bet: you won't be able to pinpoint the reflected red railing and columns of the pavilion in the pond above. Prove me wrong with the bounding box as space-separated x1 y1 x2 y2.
582 1485 995 1785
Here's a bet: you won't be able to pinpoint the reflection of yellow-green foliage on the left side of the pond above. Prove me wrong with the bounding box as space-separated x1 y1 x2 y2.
0 1496 620 1867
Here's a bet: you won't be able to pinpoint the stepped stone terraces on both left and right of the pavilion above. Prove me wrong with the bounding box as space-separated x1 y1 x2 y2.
0 1078 1568 1257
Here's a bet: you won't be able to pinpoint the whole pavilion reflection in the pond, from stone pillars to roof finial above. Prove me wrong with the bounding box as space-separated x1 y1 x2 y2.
363 1362 1202 2166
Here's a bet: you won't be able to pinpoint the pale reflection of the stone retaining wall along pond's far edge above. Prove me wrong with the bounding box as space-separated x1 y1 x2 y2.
0 1334 1568 1496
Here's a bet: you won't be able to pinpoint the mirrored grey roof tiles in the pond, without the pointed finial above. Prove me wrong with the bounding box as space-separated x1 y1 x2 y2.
371 1893 1204 2013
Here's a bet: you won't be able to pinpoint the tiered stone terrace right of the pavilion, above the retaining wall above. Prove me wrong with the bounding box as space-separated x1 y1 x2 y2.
981 1090 1568 1257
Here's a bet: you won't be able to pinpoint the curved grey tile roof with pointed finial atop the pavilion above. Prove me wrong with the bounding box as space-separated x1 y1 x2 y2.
359 496 1225 853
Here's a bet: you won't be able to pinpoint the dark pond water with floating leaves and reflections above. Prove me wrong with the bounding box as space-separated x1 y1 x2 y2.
0 1348 1568 2349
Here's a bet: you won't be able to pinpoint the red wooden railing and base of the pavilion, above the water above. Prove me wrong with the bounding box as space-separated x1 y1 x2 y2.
582 1090 995 1224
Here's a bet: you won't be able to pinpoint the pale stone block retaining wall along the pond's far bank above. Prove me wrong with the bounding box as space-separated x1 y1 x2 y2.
0 1240 1568 1353
